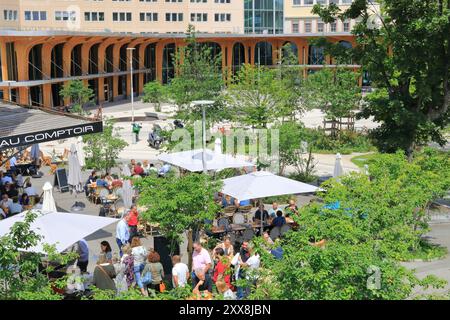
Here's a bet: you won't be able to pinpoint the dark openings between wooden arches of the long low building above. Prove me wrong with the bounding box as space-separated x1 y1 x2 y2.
19 41 351 106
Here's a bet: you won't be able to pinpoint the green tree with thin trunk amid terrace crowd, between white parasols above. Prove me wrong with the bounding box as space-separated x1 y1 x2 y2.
136 173 221 267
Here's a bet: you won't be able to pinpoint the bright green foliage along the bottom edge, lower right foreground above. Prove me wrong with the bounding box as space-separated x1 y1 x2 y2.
249 228 442 300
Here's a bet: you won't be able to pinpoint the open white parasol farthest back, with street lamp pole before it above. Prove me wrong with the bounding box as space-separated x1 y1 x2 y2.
158 149 255 172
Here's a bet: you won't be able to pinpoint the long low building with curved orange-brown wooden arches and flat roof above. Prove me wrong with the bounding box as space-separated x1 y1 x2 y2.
0 30 359 108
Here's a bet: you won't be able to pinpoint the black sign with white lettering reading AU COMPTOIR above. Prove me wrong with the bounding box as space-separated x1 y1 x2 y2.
0 121 103 150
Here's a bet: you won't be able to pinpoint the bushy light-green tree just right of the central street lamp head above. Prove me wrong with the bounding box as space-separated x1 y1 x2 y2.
225 64 281 128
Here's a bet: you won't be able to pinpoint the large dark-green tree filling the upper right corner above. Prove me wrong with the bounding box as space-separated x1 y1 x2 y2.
313 0 450 160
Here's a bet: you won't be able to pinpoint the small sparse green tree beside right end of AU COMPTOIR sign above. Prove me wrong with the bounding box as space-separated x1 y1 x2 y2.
83 119 128 172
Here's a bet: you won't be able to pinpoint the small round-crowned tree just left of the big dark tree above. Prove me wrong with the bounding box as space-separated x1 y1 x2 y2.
302 68 361 120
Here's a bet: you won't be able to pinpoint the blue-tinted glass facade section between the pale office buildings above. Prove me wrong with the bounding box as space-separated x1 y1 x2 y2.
244 0 284 34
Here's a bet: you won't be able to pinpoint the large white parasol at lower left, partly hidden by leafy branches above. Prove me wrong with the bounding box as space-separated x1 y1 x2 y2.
0 210 118 253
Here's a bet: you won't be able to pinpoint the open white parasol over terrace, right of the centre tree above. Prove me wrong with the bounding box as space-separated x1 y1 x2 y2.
222 171 322 201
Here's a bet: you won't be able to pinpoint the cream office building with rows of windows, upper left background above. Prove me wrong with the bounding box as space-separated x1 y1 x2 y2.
0 0 244 33
